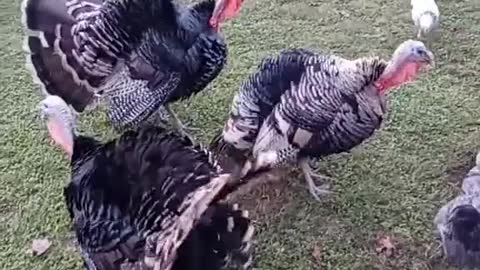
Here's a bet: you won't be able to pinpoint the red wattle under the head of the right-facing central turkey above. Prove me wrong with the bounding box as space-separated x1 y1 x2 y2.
375 63 422 93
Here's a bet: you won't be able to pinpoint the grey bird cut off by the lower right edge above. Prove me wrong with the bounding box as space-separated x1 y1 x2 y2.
434 153 480 269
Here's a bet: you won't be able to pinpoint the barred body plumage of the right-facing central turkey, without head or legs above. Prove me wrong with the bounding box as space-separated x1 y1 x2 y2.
212 47 386 168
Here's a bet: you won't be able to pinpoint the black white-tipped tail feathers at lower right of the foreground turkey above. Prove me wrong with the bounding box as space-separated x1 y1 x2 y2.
204 204 254 269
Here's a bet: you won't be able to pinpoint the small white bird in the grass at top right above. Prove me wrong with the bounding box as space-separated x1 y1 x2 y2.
411 0 440 39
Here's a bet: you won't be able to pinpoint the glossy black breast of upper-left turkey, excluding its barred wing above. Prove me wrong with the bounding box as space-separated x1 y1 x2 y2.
129 0 227 104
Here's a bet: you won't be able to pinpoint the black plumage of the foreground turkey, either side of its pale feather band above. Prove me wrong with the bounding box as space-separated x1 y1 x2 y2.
64 129 249 270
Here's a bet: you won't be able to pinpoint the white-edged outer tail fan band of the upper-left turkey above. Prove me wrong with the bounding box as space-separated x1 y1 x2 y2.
22 0 103 112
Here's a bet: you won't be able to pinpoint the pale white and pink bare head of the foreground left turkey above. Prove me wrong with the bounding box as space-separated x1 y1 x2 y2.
40 96 74 157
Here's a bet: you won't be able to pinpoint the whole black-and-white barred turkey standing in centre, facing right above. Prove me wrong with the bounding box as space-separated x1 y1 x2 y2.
210 40 434 199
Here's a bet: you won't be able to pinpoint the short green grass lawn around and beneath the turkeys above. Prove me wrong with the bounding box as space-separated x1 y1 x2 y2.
0 0 480 270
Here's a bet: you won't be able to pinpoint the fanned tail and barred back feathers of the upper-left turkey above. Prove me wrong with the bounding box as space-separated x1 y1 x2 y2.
22 0 175 112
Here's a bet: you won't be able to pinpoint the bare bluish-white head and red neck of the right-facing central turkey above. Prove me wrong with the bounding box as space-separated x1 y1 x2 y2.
375 40 435 92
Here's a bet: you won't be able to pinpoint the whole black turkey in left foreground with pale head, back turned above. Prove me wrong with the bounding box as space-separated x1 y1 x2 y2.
40 95 254 270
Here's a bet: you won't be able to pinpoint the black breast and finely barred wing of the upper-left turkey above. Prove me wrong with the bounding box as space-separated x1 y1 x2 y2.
105 0 227 127
